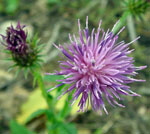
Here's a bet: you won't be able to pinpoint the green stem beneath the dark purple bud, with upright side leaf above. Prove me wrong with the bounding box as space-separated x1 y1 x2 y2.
32 68 71 134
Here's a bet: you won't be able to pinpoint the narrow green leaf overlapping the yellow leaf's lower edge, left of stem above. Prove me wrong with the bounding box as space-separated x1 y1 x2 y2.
26 109 46 122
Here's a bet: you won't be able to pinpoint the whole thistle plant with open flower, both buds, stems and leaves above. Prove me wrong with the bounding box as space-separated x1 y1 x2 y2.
1 0 149 134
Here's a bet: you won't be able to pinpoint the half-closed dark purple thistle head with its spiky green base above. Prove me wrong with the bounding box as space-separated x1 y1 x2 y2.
1 22 41 68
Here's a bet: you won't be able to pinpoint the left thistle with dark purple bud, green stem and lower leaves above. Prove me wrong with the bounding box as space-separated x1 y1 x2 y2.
1 22 75 134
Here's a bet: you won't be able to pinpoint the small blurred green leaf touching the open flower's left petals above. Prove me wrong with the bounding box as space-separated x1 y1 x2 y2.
44 75 64 82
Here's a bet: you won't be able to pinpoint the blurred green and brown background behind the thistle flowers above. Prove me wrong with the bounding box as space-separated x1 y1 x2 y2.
0 0 150 134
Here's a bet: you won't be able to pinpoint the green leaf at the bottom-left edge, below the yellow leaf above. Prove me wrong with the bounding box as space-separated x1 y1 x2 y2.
10 120 35 134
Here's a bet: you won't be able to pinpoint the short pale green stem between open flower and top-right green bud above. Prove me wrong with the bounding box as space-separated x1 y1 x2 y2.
112 11 131 34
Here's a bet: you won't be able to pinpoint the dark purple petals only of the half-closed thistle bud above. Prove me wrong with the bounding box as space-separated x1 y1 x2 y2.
1 22 27 54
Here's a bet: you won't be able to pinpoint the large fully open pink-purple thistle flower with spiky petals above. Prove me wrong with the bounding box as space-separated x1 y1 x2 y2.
47 17 146 113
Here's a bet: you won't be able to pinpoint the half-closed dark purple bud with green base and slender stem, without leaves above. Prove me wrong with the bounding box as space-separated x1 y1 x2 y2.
1 22 54 106
